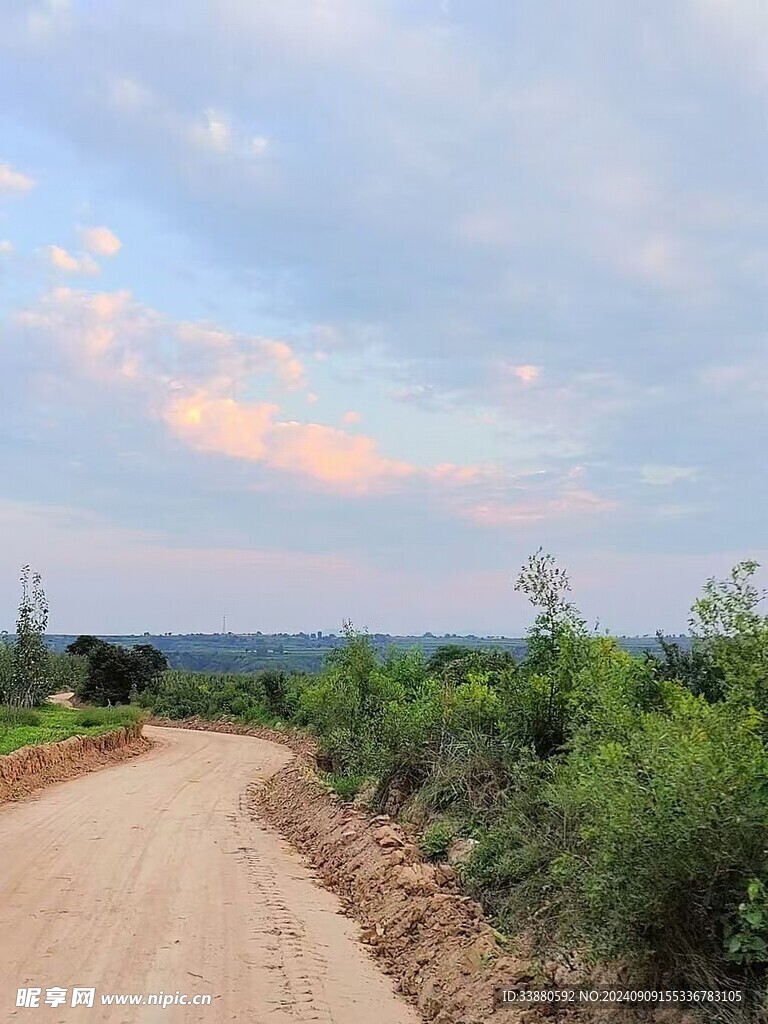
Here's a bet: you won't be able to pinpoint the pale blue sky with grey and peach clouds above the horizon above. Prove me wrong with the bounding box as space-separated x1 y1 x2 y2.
0 0 768 636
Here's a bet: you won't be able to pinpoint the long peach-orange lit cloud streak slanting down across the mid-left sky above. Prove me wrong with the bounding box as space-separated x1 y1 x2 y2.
7 288 614 522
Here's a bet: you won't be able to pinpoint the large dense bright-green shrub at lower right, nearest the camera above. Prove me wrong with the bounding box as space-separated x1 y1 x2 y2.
469 688 768 972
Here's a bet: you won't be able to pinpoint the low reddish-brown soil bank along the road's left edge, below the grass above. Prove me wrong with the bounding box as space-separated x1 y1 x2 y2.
0 722 152 804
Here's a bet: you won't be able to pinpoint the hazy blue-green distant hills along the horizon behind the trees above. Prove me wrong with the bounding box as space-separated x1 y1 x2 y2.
40 633 690 673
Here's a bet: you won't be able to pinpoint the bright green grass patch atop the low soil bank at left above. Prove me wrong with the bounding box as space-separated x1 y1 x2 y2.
0 705 142 755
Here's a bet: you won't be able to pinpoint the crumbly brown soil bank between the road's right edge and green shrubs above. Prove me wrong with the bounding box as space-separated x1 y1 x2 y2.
251 759 540 1024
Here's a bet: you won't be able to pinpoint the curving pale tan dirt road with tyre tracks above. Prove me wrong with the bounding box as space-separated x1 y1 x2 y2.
0 729 418 1024
